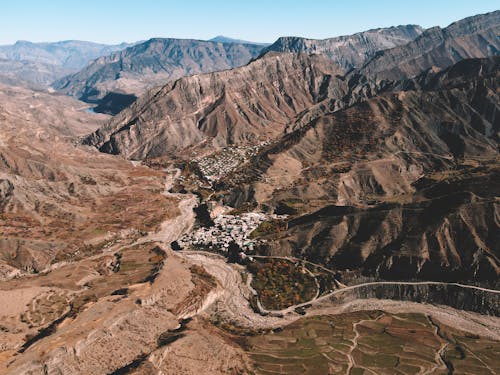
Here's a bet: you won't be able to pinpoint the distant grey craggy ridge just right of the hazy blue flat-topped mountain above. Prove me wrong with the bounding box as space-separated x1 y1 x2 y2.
263 25 423 69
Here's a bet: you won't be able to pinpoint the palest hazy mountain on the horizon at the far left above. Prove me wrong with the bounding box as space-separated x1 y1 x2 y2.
0 40 130 89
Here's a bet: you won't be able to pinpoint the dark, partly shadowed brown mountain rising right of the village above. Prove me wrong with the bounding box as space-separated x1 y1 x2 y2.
219 58 500 281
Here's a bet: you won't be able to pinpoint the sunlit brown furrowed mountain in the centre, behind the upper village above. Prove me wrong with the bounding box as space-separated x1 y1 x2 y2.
86 54 345 159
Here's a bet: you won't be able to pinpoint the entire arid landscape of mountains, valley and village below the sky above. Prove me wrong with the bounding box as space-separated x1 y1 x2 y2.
0 6 500 375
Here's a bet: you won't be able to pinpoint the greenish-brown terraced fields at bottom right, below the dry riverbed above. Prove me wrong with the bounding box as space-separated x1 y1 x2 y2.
245 311 500 374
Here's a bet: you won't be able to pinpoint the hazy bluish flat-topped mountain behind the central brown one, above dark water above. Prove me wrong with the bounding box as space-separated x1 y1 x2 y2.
53 38 262 113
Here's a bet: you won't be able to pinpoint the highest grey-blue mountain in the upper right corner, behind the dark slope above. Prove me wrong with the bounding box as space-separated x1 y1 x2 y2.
361 11 500 80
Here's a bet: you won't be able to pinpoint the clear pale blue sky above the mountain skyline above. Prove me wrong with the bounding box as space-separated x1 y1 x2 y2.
0 0 500 44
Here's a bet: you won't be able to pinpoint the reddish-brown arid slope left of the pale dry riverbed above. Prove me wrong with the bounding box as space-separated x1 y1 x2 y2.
0 86 175 279
